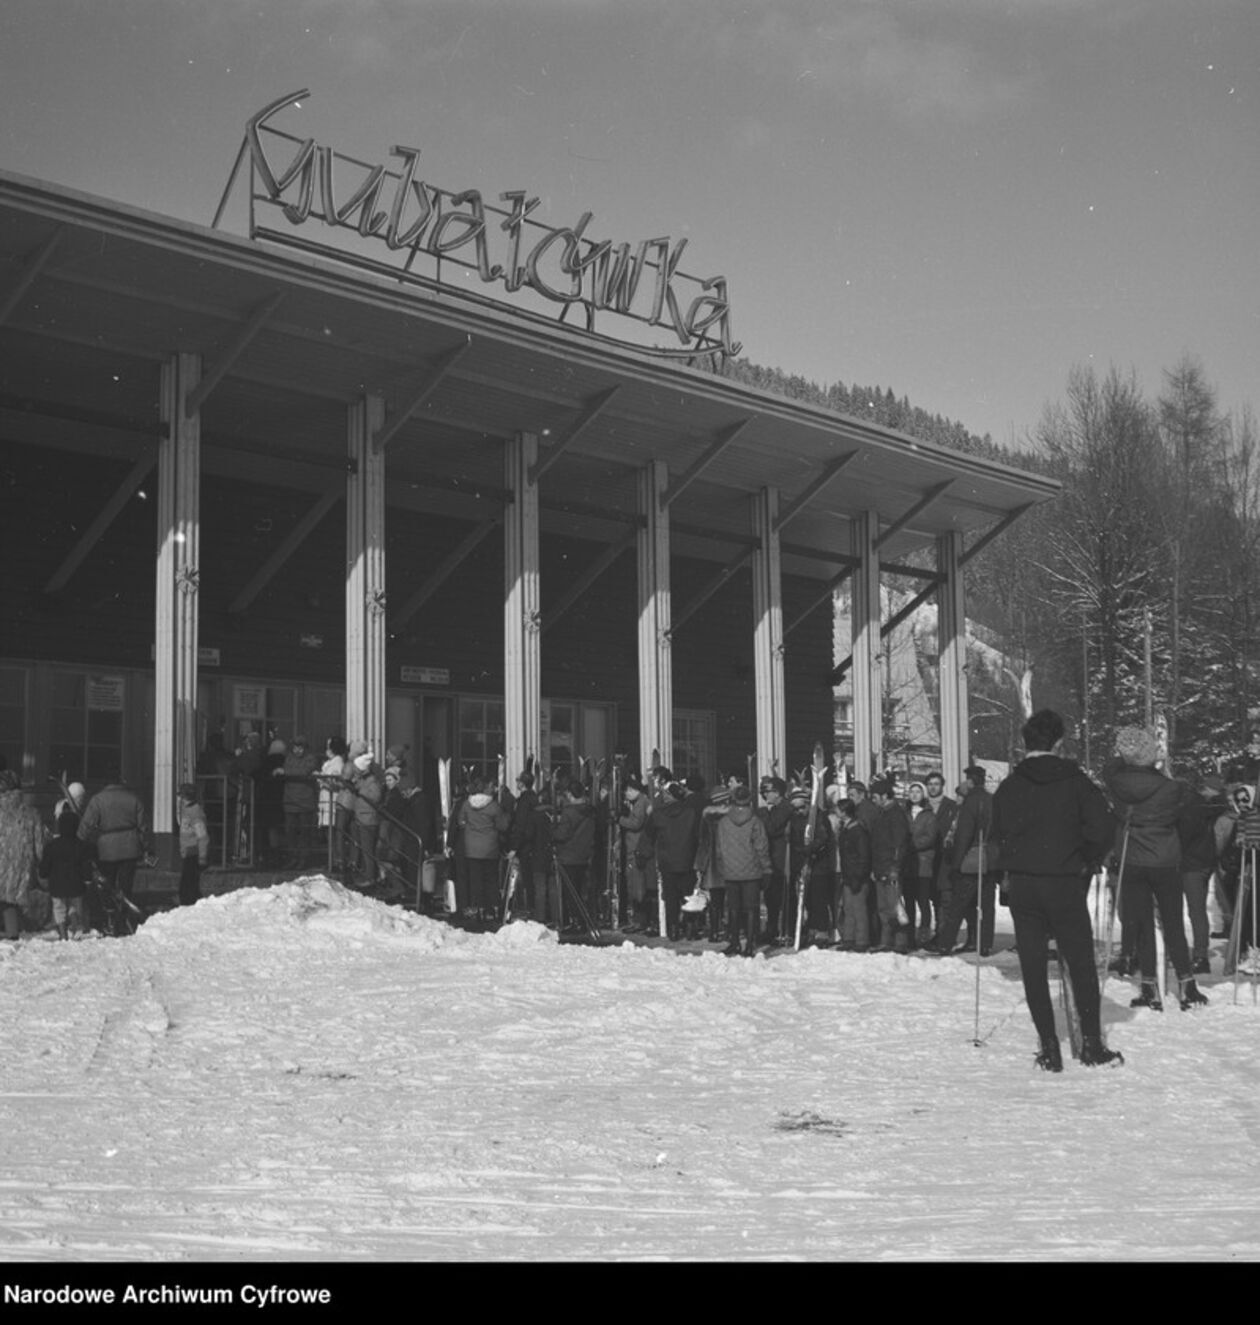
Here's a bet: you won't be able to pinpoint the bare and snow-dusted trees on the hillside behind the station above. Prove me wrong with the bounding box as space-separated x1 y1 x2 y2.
722 355 1260 771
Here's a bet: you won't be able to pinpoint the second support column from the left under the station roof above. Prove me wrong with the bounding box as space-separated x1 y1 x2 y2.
346 396 386 759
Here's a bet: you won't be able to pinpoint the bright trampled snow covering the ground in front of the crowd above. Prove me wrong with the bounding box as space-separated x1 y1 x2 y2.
0 877 1260 1261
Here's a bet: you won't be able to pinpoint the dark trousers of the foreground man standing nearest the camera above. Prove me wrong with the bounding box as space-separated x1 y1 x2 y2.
1006 875 1102 1040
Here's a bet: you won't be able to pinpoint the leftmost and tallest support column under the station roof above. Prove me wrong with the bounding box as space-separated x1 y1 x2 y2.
154 354 201 868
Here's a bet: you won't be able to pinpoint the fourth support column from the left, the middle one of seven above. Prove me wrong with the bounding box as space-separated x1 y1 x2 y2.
639 460 674 774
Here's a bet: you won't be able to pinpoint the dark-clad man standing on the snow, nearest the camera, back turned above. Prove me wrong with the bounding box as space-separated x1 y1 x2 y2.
992 709 1124 1072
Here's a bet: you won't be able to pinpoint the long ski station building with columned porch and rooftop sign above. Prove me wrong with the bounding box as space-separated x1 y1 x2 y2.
0 98 1056 858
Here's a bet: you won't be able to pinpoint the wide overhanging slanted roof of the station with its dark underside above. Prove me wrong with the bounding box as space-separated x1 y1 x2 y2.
0 172 1057 580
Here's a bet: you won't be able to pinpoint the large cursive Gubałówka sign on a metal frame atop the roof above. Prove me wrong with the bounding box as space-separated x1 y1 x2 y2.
225 89 741 359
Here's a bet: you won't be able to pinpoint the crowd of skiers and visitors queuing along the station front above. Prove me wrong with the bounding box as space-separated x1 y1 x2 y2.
0 710 1260 1044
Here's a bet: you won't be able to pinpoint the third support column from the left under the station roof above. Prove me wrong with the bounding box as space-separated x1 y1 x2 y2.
503 432 543 780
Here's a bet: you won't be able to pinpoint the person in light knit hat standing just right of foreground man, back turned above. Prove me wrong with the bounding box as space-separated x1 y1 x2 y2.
1102 727 1207 1012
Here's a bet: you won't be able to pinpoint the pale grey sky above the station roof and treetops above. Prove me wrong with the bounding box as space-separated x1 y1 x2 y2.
0 0 1260 444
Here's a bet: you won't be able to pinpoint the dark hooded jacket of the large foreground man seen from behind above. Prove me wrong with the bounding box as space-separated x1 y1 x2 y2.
991 754 1116 876
